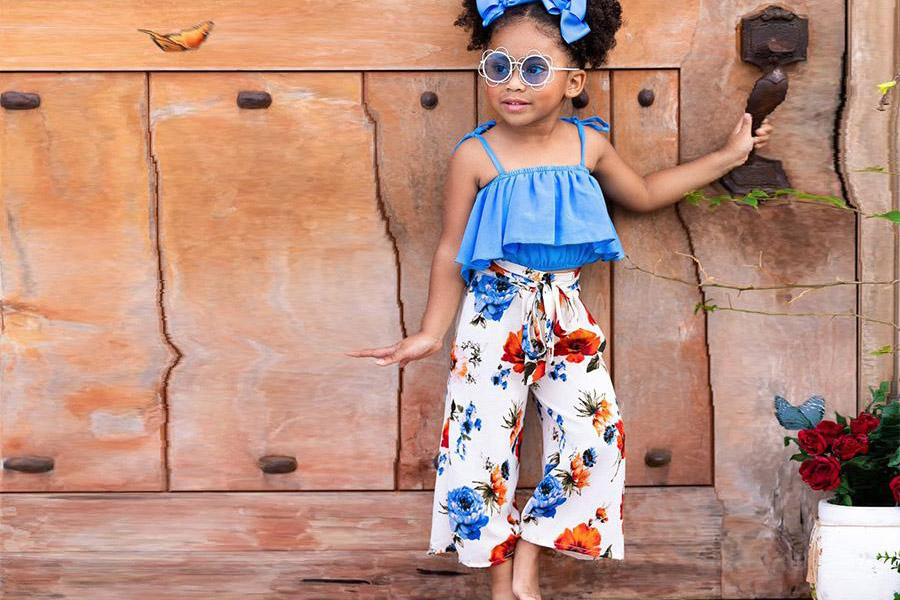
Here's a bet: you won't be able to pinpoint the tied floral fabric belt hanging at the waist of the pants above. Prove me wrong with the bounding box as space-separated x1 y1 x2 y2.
493 259 586 383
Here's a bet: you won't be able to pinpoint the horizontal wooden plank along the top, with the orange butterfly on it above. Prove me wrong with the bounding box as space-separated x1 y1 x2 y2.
0 0 696 71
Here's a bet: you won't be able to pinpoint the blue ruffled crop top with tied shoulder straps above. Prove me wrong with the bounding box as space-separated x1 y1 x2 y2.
453 117 625 284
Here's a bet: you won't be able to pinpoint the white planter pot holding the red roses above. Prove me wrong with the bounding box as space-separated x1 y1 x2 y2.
806 500 900 600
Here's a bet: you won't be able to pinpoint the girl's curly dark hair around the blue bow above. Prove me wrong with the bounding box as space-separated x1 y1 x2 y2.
453 0 622 69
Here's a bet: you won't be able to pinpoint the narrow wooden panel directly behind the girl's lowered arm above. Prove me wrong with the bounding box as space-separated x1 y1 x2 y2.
356 73 475 489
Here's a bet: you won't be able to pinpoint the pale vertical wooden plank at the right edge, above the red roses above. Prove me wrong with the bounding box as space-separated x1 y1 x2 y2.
837 2 900 414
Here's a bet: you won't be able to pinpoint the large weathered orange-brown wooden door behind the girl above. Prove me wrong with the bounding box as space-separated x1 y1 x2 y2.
0 0 856 600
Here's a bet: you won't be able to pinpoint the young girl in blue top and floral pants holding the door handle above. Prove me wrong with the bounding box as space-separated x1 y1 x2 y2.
348 0 771 600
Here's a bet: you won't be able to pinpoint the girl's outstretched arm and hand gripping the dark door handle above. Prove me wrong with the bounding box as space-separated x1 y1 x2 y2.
591 113 772 212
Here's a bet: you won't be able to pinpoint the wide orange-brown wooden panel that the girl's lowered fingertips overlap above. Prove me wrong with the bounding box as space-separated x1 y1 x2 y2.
150 73 399 490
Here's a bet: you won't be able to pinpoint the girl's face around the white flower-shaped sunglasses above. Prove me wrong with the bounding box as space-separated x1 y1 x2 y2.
480 19 587 125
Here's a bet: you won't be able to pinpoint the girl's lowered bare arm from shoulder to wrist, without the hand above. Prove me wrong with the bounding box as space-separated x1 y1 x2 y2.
420 139 482 343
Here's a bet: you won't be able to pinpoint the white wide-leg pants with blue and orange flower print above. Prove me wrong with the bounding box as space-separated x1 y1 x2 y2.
427 260 625 567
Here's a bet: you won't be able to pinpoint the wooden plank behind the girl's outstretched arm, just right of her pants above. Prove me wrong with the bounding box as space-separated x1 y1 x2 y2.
610 70 712 485
